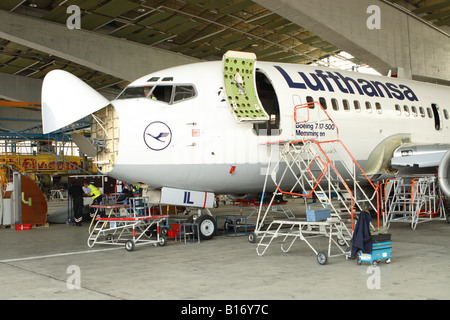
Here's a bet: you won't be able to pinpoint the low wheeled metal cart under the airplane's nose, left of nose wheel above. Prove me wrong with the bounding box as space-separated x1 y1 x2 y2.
87 205 169 251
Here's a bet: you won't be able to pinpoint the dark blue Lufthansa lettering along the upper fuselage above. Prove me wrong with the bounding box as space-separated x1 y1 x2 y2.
275 66 419 101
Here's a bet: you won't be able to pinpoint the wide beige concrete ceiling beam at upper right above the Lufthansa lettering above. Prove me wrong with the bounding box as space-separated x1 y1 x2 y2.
255 0 450 85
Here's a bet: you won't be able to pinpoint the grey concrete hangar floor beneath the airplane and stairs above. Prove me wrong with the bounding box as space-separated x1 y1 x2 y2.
0 200 450 300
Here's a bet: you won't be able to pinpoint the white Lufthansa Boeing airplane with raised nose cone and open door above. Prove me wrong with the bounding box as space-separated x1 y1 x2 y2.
42 52 450 240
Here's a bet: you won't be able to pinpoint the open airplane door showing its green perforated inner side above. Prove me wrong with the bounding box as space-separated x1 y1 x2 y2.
223 51 269 123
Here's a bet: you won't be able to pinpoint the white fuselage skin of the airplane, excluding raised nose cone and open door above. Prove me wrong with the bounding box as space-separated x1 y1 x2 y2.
105 62 450 194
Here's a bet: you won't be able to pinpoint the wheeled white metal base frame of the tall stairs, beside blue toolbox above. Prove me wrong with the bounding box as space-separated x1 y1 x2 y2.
256 218 348 265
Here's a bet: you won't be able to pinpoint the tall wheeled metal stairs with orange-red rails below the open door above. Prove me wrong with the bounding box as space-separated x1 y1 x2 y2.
249 102 380 264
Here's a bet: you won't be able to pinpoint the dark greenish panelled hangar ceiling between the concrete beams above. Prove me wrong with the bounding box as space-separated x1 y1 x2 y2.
0 0 450 97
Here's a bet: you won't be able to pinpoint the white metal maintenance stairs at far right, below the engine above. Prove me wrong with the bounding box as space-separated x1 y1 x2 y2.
383 175 446 230
